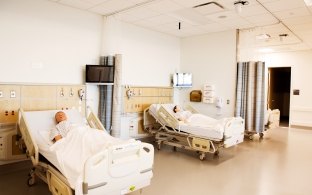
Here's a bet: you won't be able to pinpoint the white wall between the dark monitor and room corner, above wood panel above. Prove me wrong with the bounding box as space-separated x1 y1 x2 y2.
102 17 180 86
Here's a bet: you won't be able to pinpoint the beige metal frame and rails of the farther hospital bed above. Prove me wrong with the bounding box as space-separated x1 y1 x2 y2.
144 105 244 160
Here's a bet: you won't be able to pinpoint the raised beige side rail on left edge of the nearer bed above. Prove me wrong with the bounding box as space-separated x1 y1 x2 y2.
19 109 39 166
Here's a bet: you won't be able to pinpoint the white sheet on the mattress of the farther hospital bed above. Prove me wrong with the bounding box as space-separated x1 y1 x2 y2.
149 104 227 140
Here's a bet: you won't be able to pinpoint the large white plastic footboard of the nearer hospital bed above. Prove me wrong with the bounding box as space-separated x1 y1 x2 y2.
82 141 154 194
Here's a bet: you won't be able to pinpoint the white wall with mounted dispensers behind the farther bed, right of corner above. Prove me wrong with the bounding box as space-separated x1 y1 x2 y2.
177 30 236 118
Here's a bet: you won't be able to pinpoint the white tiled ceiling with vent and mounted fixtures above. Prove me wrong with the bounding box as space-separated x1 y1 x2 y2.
50 0 312 51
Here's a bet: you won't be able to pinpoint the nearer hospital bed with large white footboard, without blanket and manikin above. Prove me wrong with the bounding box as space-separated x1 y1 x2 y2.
19 109 154 195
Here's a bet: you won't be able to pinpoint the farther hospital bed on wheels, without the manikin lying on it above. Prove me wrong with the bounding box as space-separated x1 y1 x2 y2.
144 104 244 160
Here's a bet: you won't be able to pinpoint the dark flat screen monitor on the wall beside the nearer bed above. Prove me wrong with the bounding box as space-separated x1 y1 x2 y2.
86 64 114 84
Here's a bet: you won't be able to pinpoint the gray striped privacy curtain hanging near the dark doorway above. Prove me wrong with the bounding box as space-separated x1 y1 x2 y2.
235 62 265 133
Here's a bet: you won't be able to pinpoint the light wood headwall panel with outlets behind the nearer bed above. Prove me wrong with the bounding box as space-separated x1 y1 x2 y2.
0 84 86 165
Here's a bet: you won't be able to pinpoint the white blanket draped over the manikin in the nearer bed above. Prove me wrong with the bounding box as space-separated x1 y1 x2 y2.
50 126 122 190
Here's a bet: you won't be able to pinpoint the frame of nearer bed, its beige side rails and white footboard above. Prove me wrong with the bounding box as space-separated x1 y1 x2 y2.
19 109 154 195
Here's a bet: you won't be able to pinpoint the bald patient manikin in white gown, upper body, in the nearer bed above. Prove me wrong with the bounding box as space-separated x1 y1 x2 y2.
50 111 71 142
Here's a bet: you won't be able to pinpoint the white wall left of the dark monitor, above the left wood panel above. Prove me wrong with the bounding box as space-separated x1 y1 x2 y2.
0 0 102 84
